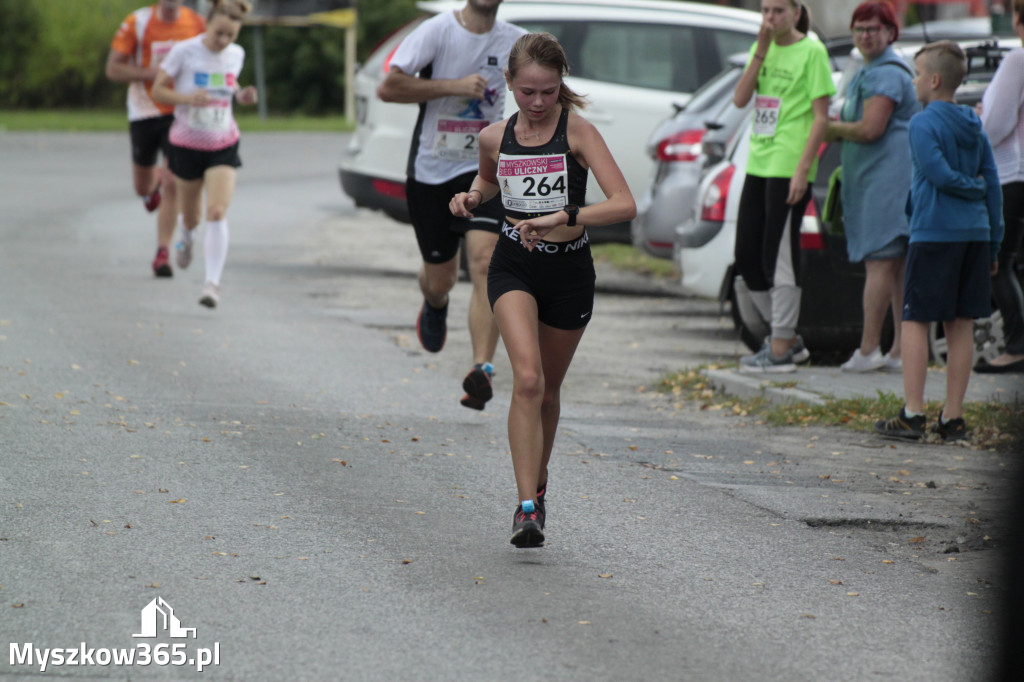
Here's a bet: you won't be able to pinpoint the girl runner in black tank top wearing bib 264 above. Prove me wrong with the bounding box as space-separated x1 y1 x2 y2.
451 34 636 547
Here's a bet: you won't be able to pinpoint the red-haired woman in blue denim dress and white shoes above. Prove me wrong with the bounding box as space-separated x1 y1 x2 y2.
827 2 921 372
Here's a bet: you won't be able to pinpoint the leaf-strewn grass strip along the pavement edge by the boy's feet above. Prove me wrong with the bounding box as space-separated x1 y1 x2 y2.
658 365 1024 452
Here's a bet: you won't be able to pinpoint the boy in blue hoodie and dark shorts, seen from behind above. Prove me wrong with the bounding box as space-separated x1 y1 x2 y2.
874 41 1002 440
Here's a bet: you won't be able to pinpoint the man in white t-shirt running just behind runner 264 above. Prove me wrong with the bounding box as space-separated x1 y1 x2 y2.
377 0 526 410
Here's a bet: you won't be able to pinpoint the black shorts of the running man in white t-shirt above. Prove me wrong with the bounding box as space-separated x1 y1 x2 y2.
406 172 505 264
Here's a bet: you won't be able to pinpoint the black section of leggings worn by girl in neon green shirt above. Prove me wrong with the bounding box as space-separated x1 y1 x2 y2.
733 175 811 291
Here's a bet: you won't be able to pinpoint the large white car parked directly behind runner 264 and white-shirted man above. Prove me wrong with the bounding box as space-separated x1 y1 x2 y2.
338 0 761 229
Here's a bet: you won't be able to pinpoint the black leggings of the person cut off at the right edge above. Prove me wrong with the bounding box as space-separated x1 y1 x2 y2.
992 182 1024 355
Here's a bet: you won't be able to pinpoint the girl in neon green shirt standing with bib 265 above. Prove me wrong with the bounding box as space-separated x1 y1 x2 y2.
733 0 836 374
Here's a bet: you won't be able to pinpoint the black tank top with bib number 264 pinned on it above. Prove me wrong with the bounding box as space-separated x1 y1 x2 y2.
498 109 587 220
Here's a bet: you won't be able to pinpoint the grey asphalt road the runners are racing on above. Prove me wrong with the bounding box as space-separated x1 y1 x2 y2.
0 133 1006 682
